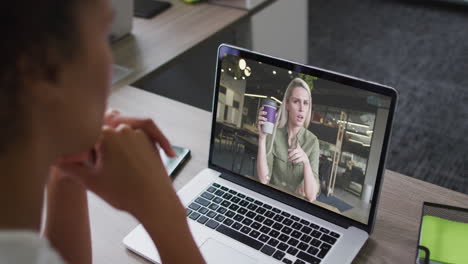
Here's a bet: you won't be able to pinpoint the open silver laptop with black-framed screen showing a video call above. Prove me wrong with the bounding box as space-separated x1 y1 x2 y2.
123 44 397 264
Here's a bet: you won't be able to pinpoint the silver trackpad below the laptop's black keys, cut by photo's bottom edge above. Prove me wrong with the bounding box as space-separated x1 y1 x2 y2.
200 238 257 264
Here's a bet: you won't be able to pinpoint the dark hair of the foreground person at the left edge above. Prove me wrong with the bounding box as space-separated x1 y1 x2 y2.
0 0 86 154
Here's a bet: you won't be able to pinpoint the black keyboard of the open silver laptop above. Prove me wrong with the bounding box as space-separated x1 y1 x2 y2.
186 183 340 264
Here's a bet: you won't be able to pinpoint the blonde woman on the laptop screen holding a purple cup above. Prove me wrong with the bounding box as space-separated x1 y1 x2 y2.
257 78 320 201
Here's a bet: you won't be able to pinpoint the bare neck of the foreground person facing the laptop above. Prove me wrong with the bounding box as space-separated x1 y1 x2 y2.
0 140 51 231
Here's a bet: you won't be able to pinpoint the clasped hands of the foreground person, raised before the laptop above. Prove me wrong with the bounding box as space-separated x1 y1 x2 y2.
59 124 183 220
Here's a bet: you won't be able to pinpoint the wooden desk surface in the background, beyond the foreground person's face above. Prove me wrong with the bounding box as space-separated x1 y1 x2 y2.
112 0 247 87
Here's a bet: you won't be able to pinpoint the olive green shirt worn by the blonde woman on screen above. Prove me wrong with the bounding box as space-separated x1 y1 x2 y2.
266 126 320 197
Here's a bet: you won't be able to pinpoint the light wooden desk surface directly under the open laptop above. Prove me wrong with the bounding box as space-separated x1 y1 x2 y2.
89 87 468 264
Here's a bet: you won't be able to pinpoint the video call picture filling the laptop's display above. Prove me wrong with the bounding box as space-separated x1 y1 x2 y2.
212 55 390 224
